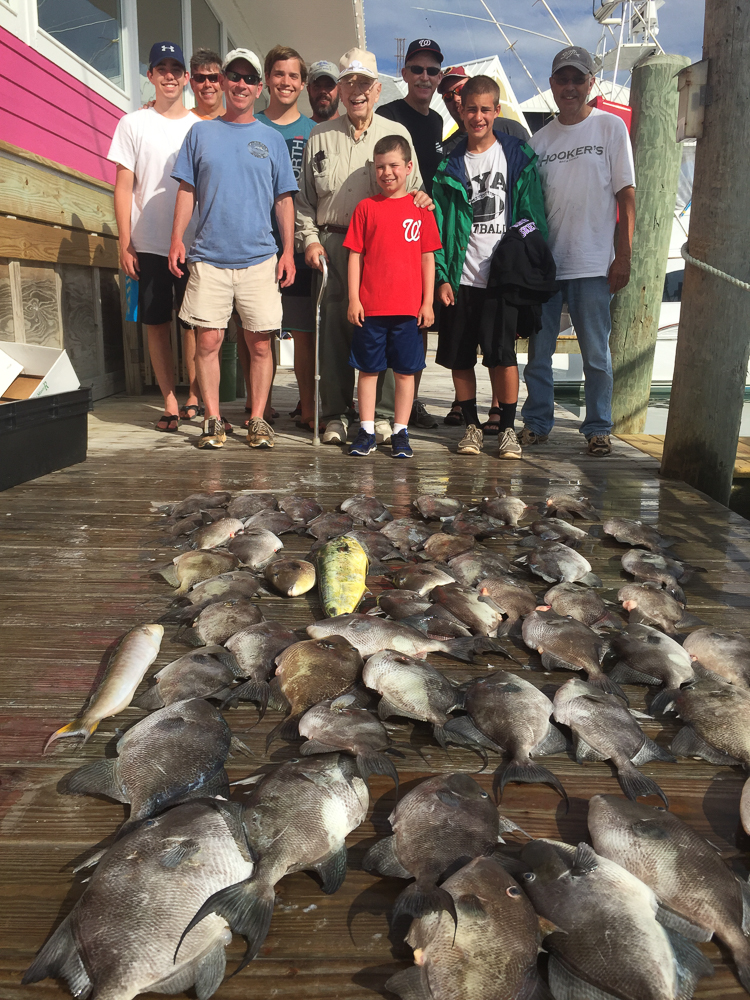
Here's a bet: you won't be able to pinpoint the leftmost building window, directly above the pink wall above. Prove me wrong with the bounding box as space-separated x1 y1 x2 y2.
37 0 123 87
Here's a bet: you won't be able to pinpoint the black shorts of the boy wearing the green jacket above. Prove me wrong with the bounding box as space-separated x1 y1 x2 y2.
435 285 518 371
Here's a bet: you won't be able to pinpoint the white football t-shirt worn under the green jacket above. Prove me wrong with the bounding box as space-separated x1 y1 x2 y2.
461 142 508 288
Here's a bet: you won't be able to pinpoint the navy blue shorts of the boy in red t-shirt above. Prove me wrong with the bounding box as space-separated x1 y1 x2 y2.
349 316 425 375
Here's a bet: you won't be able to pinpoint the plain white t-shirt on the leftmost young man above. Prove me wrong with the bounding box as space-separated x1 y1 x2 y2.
107 108 200 257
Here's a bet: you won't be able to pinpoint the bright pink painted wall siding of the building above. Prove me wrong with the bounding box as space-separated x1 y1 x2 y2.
0 28 125 184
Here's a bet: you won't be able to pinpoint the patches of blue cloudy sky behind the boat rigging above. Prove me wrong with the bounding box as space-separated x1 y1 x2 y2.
364 0 704 101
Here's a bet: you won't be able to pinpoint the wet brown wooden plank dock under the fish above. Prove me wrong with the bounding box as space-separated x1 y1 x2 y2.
0 375 750 1000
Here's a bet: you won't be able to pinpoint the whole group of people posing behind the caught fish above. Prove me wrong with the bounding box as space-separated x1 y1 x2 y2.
109 38 635 459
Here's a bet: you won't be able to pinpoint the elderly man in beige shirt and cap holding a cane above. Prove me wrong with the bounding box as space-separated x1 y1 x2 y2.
295 48 431 444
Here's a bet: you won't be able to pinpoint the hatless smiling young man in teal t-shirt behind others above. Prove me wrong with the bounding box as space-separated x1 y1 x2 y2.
258 45 315 428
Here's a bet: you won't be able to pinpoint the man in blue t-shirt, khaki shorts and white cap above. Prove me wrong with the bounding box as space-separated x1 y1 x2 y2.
169 49 297 448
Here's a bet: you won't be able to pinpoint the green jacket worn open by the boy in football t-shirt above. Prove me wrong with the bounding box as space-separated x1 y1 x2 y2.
432 132 548 294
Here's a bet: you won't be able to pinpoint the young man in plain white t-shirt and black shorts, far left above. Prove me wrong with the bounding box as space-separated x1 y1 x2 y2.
107 42 200 431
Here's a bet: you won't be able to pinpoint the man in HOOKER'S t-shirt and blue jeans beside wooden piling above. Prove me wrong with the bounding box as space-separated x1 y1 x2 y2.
521 46 635 455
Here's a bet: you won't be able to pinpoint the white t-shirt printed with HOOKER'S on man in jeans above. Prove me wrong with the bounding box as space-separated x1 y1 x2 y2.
529 108 635 280
